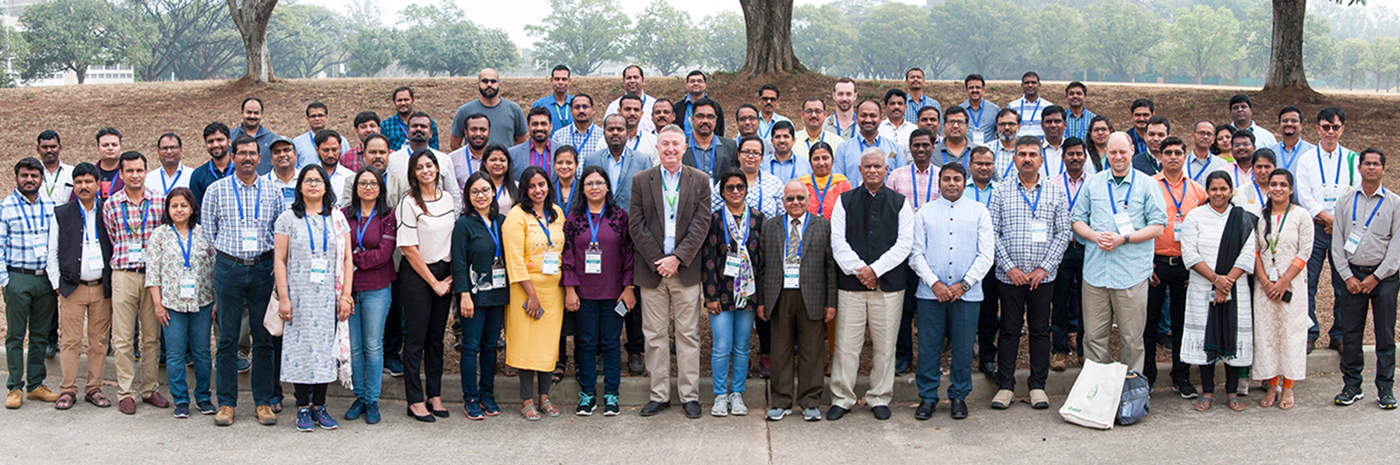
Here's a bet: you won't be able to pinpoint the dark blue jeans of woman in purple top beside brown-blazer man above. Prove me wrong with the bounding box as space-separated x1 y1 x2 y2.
574 298 623 395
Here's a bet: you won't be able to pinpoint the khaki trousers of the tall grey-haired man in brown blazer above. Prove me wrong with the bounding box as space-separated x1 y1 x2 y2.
641 277 700 402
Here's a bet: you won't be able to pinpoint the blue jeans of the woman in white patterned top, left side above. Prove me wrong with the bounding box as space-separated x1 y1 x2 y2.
164 304 214 405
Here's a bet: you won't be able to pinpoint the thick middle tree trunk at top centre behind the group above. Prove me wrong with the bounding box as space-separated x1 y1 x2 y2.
739 0 805 76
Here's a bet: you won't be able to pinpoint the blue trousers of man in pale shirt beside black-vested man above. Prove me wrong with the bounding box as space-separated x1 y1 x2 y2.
916 298 981 402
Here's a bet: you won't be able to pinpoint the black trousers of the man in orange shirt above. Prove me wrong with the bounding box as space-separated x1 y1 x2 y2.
1142 255 1190 385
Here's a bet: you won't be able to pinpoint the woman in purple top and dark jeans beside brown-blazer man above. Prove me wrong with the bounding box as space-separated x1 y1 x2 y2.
560 167 637 416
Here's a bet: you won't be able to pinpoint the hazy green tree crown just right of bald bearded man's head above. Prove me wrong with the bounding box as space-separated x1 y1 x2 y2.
525 0 631 76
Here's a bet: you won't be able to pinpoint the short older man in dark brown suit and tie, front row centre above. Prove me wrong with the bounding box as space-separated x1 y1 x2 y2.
759 179 836 422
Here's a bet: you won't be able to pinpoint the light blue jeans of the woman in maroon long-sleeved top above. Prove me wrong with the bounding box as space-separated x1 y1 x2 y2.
350 286 391 402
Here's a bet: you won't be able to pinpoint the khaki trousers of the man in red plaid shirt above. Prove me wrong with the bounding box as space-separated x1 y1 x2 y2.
112 270 161 399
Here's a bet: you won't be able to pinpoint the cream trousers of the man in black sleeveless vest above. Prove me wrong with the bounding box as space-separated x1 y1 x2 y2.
832 290 904 409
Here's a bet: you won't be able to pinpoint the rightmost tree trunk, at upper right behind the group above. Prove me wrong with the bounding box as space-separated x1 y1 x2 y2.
1264 0 1322 101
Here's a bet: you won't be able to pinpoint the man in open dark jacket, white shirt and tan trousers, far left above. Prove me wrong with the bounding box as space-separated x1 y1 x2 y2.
48 162 112 410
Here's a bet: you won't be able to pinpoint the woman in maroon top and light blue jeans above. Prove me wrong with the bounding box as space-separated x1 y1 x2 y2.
343 165 398 424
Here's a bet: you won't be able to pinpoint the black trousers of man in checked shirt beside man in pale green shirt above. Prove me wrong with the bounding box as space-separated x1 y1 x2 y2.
994 279 1054 389
